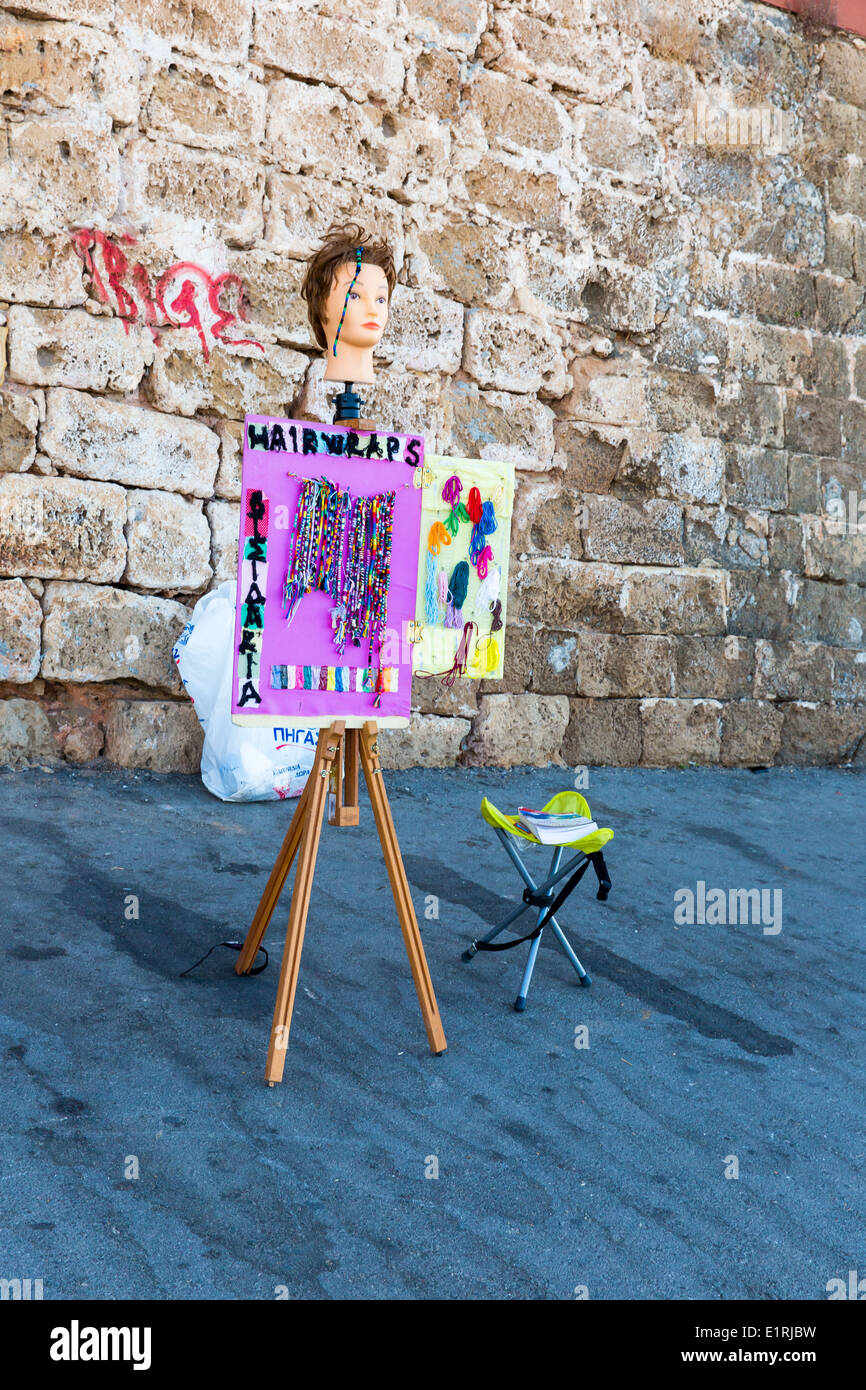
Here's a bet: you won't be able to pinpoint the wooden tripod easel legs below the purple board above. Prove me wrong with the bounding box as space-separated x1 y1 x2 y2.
235 720 446 1086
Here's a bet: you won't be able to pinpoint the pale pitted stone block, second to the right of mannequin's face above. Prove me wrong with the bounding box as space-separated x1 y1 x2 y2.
463 309 571 398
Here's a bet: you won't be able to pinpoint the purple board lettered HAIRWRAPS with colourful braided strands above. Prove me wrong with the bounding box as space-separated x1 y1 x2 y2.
232 416 424 727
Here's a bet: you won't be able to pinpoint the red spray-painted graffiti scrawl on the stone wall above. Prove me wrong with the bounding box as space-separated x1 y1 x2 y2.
72 227 264 361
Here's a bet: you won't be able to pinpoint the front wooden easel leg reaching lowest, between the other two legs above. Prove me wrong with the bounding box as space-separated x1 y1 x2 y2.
264 720 345 1086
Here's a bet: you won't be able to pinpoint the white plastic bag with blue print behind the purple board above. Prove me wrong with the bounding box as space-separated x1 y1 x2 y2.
171 580 317 801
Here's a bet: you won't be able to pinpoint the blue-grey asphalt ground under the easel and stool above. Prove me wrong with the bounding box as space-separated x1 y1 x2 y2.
0 767 866 1300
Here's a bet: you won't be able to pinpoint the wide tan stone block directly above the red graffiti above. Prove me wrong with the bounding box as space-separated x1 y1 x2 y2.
124 139 264 246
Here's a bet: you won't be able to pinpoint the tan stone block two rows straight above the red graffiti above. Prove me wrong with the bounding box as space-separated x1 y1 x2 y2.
143 53 265 154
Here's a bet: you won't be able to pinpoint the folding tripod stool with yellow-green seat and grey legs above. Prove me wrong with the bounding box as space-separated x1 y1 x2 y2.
463 791 613 1013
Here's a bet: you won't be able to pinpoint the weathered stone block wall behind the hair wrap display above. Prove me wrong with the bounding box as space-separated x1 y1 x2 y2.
0 0 866 770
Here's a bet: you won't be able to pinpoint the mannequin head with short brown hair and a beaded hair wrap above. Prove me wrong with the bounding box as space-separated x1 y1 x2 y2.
300 222 396 382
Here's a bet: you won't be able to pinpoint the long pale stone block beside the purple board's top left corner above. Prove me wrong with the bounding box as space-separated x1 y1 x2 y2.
39 389 218 498
